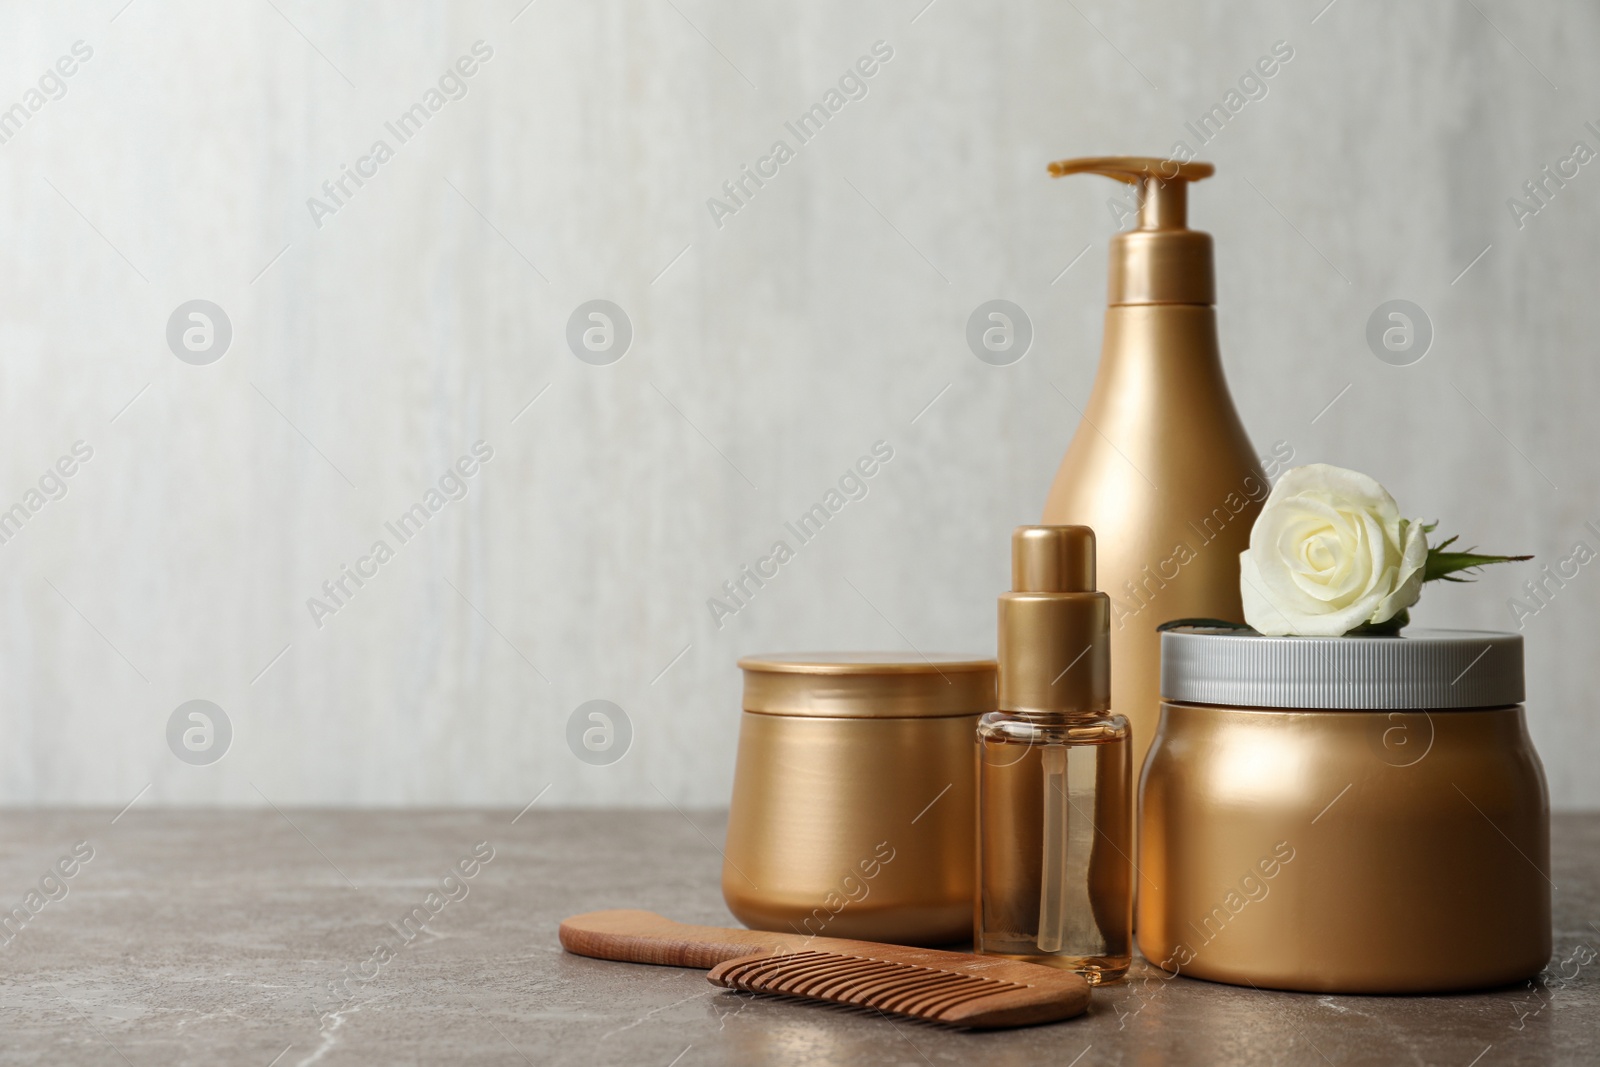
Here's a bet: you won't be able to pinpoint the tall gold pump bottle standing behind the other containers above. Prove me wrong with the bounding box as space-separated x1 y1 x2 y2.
1045 157 1270 783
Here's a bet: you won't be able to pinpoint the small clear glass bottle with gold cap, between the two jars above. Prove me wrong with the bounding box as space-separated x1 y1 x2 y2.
974 526 1133 985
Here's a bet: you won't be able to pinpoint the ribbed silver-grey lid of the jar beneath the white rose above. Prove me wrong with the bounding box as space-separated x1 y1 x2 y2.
1162 625 1523 710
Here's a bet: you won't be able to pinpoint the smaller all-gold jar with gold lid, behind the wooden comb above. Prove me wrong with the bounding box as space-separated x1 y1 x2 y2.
722 653 995 945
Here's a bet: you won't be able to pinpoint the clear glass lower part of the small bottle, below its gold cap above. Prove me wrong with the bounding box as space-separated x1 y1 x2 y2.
974 712 1133 985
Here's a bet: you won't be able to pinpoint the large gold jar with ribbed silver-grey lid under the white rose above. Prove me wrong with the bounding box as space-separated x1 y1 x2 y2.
1138 627 1550 993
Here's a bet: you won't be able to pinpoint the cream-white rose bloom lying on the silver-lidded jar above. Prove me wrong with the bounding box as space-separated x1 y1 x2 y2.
1238 464 1427 637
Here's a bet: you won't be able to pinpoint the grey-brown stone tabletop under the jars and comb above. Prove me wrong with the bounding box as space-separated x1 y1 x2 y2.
0 808 1600 1067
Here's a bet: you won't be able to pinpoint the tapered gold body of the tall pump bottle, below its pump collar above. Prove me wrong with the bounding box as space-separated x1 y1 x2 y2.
1043 304 1270 774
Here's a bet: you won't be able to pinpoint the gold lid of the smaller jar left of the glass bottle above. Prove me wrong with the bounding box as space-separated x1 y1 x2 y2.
739 653 995 718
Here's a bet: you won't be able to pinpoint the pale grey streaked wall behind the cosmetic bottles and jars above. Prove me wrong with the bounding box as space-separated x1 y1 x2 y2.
0 0 1600 808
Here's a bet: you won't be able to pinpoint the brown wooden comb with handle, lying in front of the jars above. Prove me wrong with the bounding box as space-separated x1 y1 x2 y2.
560 910 1090 1029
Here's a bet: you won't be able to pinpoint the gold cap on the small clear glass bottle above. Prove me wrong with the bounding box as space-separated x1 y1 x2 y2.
998 526 1110 718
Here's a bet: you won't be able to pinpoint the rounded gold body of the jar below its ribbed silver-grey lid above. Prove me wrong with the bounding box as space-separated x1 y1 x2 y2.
1138 704 1550 993
